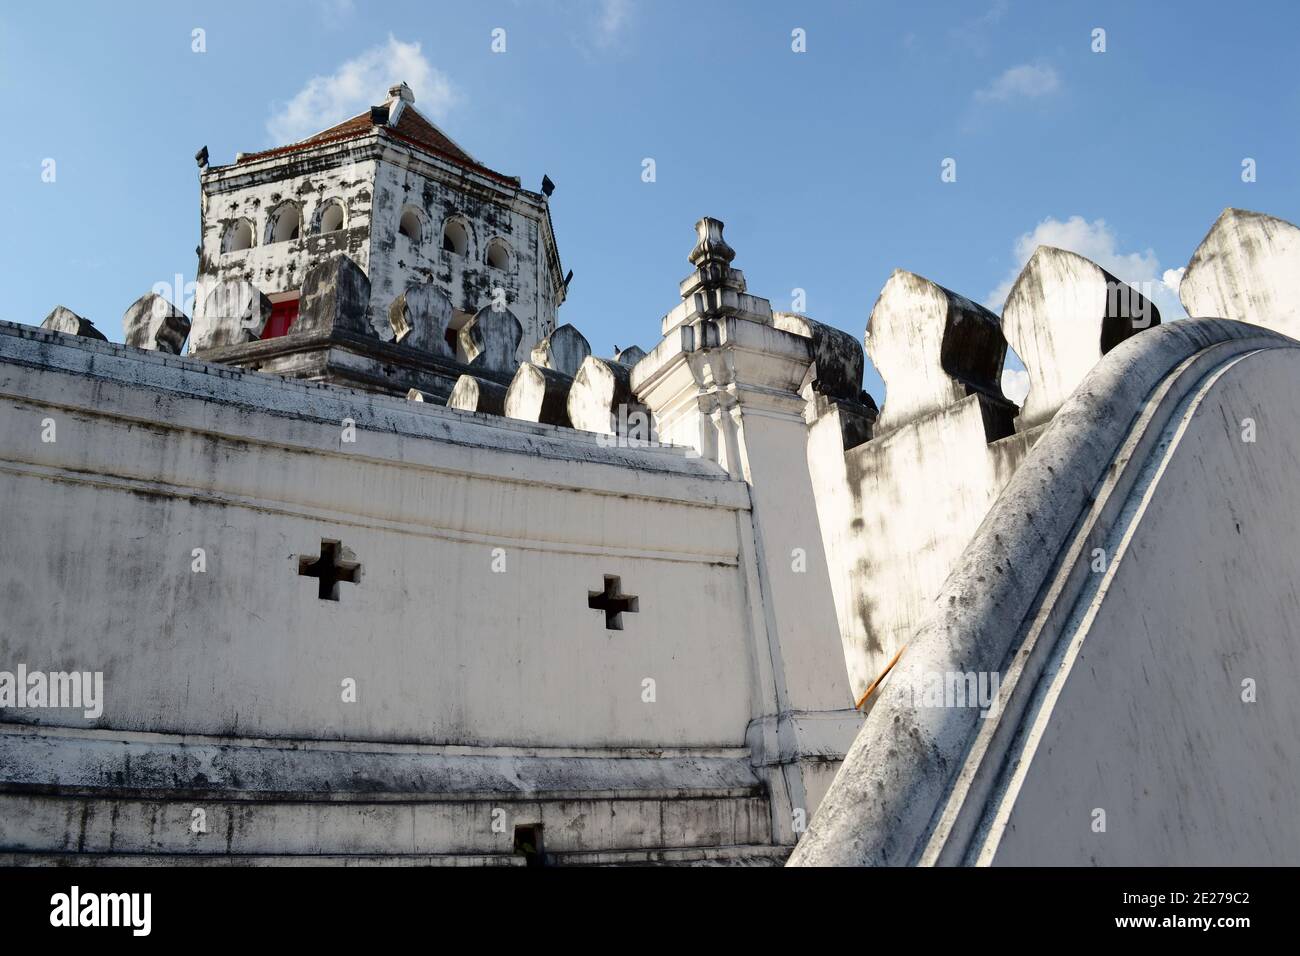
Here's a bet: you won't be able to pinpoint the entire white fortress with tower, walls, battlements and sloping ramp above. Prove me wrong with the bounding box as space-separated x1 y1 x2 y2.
0 86 1300 865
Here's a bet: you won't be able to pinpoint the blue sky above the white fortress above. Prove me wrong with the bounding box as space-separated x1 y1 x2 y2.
0 0 1300 399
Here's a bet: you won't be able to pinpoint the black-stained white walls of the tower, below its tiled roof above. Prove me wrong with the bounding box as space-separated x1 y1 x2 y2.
194 133 563 369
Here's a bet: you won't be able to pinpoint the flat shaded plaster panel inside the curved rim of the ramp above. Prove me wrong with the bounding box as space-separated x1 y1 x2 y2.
978 349 1300 865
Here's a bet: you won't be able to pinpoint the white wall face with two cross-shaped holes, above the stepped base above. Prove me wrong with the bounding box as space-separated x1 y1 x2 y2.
0 326 757 747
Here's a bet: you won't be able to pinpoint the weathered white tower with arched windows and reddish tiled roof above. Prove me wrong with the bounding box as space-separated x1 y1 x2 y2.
190 83 567 393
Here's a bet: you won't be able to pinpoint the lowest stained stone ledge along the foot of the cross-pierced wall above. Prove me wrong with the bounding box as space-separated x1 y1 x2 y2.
0 791 771 865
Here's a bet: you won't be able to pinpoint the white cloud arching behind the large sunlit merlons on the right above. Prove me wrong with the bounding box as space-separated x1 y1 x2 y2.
984 216 1183 320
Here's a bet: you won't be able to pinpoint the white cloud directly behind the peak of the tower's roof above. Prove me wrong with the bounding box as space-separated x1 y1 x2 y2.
267 36 459 146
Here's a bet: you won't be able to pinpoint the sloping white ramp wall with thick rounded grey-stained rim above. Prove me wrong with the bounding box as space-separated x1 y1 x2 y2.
790 319 1300 865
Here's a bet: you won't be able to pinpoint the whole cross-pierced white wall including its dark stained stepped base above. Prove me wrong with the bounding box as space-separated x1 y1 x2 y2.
0 324 811 862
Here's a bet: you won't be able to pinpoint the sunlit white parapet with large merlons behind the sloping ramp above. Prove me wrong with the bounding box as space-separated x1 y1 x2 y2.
807 209 1300 712
